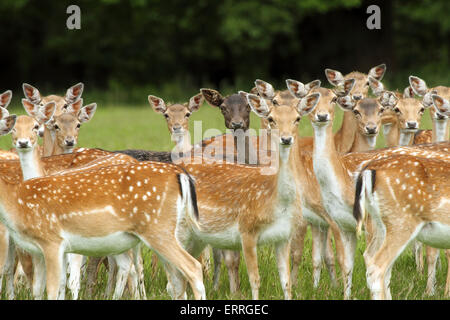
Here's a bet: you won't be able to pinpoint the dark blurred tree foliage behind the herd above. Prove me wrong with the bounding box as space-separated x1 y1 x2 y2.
0 0 450 103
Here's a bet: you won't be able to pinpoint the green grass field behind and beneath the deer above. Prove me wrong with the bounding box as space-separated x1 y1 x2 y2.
0 101 447 299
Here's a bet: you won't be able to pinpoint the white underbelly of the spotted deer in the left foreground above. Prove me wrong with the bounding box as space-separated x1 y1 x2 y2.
62 232 140 256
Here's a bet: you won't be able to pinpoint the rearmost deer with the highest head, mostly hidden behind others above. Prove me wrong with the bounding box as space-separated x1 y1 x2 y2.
325 63 386 153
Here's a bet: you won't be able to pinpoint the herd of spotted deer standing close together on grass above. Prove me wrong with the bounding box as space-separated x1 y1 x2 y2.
0 64 450 299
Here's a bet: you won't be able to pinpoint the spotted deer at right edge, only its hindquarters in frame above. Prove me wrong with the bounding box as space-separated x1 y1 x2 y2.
354 151 450 299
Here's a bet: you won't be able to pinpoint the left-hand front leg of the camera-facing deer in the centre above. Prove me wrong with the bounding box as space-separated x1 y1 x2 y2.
241 233 260 300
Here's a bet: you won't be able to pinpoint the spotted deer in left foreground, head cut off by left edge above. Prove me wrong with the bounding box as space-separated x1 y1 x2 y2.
0 116 204 299
